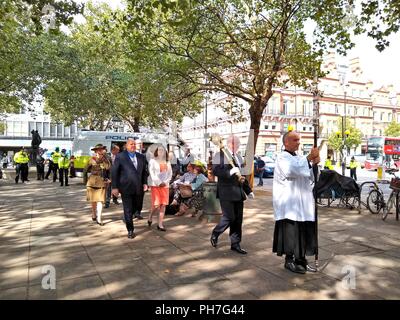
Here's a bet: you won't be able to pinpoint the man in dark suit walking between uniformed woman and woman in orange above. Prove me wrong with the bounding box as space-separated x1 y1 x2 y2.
111 138 148 239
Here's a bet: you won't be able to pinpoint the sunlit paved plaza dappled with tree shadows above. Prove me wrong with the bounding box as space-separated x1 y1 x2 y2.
0 171 400 300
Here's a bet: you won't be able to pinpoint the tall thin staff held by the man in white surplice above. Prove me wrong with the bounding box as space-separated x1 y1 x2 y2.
313 76 319 270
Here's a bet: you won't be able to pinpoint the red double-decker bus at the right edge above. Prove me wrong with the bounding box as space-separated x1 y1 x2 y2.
365 137 400 170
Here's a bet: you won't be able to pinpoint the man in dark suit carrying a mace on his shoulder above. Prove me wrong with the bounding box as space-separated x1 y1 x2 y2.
211 136 247 254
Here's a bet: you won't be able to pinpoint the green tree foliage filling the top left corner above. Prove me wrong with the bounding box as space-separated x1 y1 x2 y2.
0 0 83 113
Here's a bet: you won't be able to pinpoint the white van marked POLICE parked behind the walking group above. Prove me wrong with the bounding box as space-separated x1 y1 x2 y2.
72 131 184 176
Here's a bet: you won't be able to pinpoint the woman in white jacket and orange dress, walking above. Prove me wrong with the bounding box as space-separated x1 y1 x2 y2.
147 145 172 231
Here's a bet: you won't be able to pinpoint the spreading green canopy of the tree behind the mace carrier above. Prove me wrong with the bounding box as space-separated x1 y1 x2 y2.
120 0 360 151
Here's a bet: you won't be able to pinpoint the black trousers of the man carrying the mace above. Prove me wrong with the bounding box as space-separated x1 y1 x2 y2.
212 200 243 246
